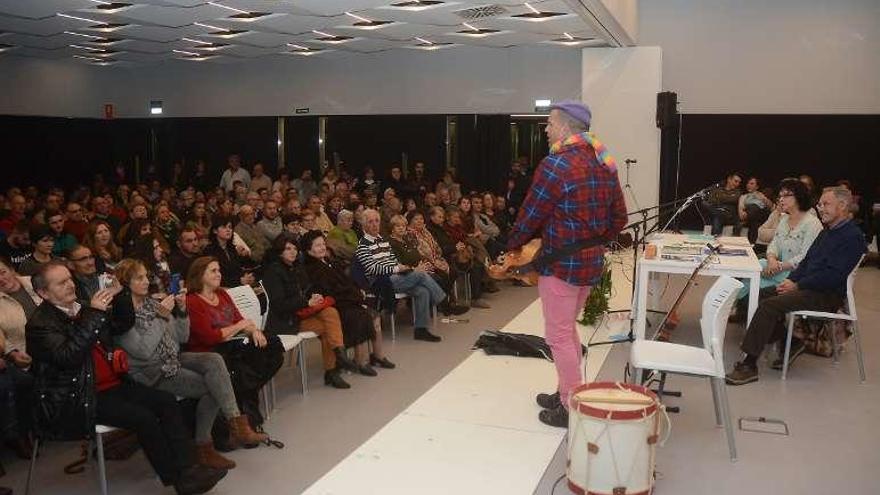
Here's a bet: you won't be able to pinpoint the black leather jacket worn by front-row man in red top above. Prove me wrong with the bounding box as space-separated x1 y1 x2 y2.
26 301 111 440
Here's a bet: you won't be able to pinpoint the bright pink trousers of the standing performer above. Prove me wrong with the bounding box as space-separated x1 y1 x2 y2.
538 276 590 409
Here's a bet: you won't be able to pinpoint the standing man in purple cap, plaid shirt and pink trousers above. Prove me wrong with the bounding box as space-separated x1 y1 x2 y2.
507 101 627 428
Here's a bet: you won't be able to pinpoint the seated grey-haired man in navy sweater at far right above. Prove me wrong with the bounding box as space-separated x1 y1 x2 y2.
727 187 865 385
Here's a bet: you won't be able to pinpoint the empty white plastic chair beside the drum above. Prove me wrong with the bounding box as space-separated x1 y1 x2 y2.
629 275 743 461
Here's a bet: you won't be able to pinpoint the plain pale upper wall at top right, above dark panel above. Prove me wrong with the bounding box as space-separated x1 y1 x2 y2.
639 0 880 114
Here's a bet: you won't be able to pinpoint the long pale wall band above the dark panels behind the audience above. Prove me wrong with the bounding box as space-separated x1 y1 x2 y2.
0 46 581 117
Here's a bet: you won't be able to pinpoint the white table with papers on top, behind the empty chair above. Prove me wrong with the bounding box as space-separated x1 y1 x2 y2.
633 233 761 339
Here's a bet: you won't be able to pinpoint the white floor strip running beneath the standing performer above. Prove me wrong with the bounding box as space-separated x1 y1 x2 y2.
304 265 630 495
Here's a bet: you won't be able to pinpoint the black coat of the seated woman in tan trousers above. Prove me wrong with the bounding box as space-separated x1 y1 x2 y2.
263 260 311 335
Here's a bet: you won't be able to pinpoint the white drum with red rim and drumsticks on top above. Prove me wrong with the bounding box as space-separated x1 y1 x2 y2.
566 382 668 495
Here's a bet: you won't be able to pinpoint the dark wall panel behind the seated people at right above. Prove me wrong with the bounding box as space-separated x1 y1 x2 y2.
661 114 880 226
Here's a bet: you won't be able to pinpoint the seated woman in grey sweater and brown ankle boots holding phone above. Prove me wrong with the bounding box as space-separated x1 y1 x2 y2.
113 259 268 469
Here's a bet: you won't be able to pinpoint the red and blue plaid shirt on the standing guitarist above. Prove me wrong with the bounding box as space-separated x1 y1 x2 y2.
507 134 627 286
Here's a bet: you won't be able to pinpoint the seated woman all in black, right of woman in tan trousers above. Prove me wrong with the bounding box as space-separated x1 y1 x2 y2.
300 230 395 376
